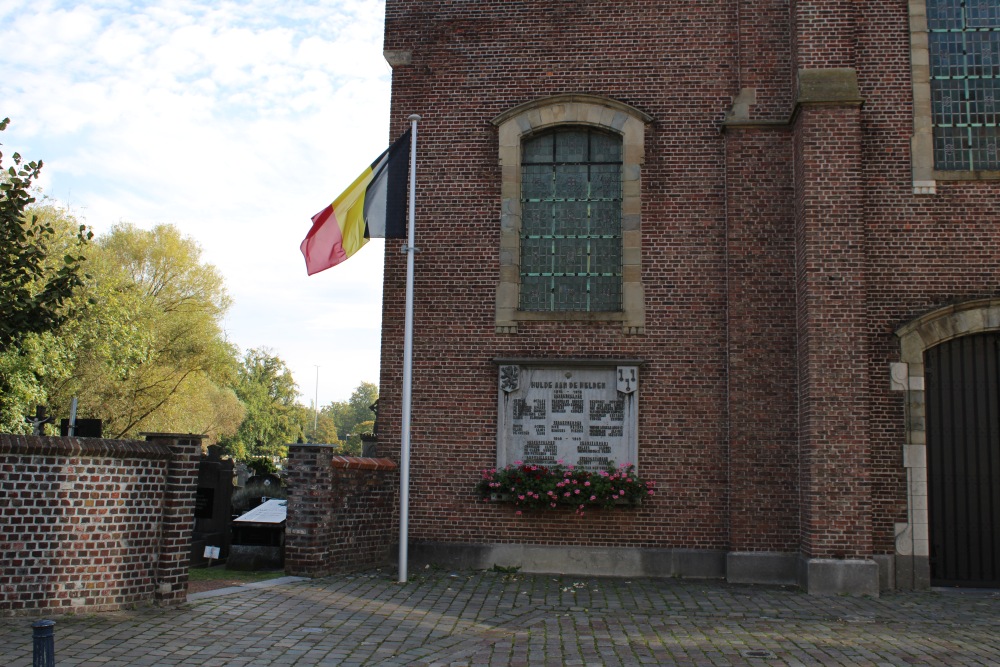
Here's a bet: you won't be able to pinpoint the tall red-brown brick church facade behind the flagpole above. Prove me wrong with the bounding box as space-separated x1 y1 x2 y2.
379 0 1000 580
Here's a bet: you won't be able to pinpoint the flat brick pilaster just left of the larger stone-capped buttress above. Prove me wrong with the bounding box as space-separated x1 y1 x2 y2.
726 121 799 583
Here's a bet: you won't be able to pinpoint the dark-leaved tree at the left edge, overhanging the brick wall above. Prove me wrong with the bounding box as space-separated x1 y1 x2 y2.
0 118 93 350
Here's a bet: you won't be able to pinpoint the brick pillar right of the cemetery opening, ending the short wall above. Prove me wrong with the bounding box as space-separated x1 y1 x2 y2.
285 444 334 577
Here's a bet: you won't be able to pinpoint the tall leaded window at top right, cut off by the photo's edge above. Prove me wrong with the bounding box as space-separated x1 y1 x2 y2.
927 0 1000 171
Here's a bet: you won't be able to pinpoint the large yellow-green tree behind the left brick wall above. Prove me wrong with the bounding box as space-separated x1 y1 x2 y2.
55 224 242 442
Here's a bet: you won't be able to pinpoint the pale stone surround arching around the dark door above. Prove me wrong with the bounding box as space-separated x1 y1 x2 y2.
891 299 1000 588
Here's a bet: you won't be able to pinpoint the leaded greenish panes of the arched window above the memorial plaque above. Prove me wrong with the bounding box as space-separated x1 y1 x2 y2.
519 128 622 312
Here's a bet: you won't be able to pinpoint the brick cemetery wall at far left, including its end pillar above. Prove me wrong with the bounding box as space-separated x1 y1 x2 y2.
0 435 200 614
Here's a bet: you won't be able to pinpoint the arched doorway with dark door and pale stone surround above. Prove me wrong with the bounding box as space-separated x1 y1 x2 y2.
891 299 1000 588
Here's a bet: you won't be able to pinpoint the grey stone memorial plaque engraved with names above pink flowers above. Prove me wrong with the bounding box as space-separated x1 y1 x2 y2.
497 364 639 472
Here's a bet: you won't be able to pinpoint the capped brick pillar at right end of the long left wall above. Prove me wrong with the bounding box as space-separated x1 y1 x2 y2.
142 433 204 605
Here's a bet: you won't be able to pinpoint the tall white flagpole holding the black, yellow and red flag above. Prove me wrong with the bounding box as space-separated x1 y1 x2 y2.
399 114 420 584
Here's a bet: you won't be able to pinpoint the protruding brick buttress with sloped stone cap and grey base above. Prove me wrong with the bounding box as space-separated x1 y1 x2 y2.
794 69 878 595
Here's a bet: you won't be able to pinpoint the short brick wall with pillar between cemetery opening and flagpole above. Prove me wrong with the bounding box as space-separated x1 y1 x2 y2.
285 444 399 577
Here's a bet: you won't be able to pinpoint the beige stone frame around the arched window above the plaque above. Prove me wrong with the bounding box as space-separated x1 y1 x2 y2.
492 95 652 334
